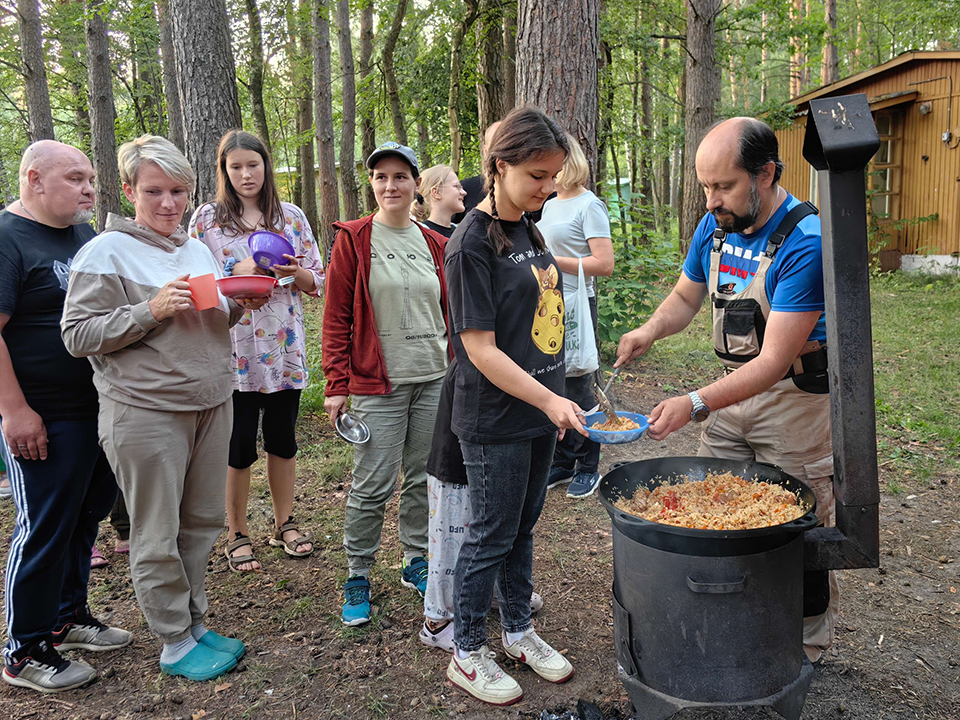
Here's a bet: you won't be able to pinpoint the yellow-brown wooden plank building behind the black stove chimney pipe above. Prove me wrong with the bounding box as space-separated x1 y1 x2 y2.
777 51 960 270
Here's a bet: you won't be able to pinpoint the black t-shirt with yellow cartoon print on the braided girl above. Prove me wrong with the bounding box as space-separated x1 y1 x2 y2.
444 209 566 444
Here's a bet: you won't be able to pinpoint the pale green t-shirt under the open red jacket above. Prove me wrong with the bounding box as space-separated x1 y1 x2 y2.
370 220 448 384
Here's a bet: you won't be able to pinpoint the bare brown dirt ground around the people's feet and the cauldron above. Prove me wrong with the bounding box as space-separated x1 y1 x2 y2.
0 377 960 720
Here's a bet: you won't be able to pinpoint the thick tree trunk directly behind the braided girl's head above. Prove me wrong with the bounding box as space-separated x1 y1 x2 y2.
517 0 600 187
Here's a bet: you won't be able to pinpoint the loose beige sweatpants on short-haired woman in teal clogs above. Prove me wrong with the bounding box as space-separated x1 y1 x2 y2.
100 395 233 643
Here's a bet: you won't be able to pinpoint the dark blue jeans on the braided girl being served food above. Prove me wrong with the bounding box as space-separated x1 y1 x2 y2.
454 433 557 652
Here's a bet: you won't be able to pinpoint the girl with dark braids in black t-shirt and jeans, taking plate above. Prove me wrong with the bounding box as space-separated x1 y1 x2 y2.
441 107 586 705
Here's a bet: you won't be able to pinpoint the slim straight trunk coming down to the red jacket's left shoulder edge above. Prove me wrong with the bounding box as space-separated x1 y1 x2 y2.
313 0 340 257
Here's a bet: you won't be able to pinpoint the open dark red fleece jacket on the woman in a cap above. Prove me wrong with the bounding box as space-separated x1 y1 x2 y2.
321 215 452 397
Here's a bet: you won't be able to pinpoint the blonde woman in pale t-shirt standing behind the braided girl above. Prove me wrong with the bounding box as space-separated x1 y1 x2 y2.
537 135 613 497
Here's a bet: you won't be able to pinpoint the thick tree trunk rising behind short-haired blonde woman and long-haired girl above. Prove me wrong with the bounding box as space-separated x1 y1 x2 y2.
170 0 242 206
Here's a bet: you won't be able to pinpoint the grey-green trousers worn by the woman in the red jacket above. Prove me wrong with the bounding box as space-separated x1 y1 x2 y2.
343 378 443 574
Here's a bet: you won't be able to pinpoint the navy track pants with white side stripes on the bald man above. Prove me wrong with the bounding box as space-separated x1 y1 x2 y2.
3 419 117 658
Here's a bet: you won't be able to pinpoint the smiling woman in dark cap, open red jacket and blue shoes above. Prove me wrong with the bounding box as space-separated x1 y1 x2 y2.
322 142 450 625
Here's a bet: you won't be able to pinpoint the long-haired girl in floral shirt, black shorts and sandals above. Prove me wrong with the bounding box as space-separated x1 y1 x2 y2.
190 130 323 572
